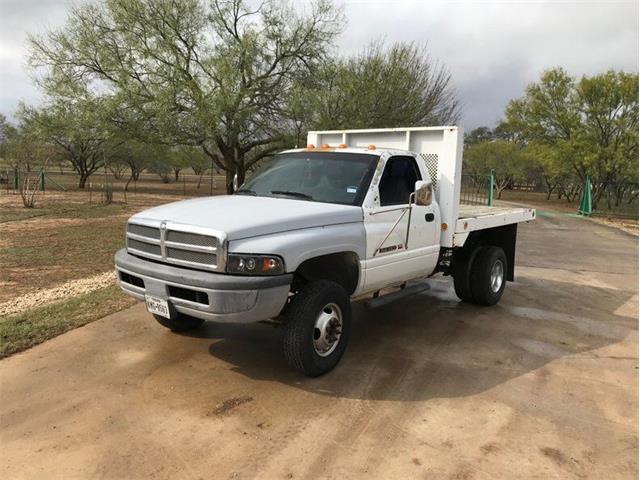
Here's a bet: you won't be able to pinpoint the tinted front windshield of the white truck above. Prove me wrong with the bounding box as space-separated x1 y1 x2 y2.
236 152 379 205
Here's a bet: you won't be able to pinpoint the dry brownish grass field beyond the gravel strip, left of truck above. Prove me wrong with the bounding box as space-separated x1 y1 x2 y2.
0 203 135 302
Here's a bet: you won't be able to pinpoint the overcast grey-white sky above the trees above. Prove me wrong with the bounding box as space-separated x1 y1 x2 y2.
0 0 639 129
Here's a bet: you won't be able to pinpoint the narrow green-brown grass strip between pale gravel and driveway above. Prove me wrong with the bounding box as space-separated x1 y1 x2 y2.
0 285 136 358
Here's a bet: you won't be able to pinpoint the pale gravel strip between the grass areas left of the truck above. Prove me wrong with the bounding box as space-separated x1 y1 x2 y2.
0 271 116 317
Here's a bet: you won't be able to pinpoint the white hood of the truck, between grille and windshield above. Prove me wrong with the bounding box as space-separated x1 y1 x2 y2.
131 195 363 240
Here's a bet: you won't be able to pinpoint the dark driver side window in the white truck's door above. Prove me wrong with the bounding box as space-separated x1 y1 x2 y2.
378 157 422 207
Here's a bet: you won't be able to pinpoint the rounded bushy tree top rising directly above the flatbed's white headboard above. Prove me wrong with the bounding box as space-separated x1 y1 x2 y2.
292 42 461 142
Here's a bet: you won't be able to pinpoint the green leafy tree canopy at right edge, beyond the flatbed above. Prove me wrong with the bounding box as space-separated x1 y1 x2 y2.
502 68 638 203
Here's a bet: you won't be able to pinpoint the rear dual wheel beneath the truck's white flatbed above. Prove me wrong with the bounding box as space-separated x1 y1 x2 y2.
453 245 507 305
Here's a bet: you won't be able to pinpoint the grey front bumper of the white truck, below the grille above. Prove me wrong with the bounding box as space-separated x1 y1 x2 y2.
115 248 293 323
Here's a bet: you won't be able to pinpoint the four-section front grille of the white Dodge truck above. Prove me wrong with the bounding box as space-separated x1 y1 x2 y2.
127 222 226 271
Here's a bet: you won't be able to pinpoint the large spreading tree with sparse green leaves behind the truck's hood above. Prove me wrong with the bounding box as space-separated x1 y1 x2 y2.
30 0 342 190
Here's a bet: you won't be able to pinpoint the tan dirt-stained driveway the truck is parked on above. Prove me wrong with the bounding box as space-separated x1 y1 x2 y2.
0 215 638 479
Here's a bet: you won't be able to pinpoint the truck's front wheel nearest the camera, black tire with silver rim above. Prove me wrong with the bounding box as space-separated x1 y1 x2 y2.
283 280 351 377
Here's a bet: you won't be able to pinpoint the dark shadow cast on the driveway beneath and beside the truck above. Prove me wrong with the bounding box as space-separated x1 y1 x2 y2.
194 278 637 401
